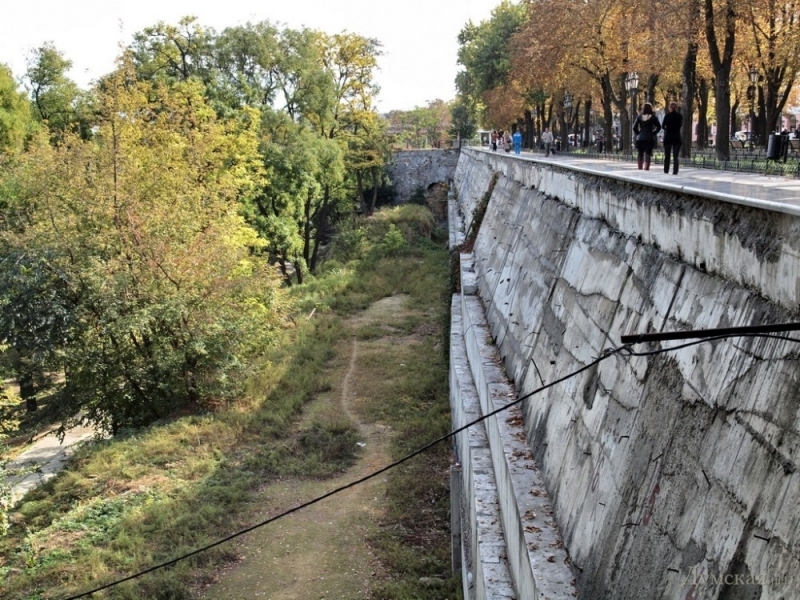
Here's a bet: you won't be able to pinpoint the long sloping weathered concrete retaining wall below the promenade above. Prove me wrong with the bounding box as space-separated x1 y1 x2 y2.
455 150 800 600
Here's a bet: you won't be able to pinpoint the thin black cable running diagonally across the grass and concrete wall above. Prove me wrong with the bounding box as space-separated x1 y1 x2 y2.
64 333 800 600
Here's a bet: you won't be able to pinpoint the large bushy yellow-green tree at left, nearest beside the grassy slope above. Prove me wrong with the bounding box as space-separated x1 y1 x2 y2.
0 67 283 431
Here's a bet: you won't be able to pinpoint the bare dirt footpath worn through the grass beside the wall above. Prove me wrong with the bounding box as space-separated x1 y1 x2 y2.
201 296 414 600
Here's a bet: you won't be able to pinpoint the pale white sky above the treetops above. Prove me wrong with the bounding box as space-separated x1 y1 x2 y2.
0 0 501 112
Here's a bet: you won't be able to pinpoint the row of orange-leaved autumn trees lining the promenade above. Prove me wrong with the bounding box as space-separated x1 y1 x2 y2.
456 0 800 155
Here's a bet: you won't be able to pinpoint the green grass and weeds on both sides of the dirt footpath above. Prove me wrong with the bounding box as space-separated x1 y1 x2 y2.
0 206 456 600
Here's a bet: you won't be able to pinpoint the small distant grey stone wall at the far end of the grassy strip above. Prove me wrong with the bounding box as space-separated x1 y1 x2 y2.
388 150 458 203
